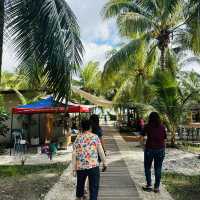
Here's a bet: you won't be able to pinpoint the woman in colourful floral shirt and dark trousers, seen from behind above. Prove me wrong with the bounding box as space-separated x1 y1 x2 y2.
72 120 106 200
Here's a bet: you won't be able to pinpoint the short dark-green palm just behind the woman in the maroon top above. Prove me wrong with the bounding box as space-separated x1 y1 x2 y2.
150 69 199 146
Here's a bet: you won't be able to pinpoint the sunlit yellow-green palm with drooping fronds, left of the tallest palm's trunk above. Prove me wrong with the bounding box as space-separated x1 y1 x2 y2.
102 40 158 103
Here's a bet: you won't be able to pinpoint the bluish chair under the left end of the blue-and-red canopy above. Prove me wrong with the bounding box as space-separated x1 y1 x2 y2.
12 129 26 153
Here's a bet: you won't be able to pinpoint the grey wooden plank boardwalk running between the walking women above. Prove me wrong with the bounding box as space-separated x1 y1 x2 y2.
98 127 141 200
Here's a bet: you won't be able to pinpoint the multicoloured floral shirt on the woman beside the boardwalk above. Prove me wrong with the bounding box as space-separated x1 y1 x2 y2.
74 131 101 170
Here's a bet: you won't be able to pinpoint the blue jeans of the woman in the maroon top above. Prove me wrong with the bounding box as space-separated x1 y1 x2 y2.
144 149 165 188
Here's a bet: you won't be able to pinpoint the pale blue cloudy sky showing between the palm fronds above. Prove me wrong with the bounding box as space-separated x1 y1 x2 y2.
3 0 200 73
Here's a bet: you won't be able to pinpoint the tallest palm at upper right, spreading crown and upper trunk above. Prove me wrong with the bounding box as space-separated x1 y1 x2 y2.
103 0 200 69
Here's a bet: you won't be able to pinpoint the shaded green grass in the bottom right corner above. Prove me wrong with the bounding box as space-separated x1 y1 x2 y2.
163 173 200 200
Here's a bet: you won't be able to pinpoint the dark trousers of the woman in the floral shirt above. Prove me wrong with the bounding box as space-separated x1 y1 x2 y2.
76 167 100 200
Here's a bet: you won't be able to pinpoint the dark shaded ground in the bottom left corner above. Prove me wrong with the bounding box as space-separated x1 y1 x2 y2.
0 172 59 200
